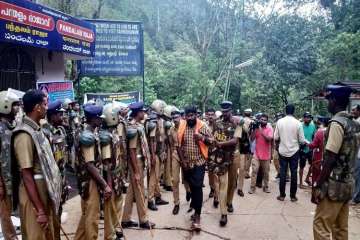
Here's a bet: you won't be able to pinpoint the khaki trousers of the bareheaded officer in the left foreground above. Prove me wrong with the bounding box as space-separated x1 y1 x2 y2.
19 180 55 240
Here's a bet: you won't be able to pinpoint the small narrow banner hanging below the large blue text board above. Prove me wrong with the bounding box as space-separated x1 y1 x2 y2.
84 92 140 105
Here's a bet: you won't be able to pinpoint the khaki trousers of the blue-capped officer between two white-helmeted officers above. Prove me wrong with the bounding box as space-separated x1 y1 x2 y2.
122 160 147 223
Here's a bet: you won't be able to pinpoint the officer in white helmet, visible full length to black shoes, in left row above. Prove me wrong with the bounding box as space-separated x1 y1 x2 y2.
145 100 169 211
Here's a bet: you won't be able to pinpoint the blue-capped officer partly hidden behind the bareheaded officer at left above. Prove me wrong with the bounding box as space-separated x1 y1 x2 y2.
42 100 69 239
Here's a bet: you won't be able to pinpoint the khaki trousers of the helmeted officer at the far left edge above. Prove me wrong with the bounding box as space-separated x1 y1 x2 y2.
0 196 17 240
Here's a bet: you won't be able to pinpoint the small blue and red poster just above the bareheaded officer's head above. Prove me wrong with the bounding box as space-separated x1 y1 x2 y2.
36 81 75 102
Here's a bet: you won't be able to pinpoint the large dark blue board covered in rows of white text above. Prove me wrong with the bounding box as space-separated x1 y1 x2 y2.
78 20 144 76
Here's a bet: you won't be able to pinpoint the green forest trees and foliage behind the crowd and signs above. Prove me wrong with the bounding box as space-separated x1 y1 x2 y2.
37 0 360 114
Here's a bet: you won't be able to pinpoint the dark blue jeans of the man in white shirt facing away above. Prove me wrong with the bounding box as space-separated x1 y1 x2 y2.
279 152 299 198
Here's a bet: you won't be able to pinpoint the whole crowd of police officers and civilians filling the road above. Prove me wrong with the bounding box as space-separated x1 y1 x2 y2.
0 85 360 240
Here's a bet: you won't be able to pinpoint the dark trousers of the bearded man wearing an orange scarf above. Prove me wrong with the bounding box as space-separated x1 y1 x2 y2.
185 166 205 215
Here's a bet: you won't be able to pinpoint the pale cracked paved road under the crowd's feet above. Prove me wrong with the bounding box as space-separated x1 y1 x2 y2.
60 166 360 240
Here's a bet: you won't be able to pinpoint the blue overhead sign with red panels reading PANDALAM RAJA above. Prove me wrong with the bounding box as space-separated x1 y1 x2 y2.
0 0 95 57
